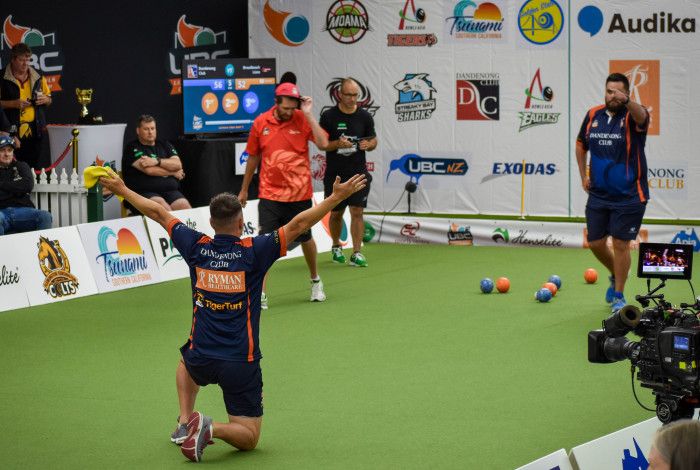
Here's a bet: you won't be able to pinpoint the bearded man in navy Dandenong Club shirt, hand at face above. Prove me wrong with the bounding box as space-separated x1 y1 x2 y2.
576 73 649 313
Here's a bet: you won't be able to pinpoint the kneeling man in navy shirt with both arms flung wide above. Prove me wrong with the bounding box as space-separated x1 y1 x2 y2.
100 175 366 462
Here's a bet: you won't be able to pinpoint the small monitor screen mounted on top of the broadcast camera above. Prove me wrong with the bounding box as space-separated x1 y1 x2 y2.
637 243 693 279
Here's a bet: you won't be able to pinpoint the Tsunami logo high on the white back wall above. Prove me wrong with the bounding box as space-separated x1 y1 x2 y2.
445 0 503 40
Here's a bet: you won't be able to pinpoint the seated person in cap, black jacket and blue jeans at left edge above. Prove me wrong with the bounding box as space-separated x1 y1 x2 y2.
0 135 52 235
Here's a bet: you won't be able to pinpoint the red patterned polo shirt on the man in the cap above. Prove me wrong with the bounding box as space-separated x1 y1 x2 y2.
246 107 326 202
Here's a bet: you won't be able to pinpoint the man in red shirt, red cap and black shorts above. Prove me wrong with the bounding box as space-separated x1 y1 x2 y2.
238 83 328 309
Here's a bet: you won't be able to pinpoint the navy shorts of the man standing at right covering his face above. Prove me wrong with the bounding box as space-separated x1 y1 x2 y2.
586 200 647 242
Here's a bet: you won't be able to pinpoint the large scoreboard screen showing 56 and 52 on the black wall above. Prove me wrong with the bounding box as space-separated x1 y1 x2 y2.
182 59 276 134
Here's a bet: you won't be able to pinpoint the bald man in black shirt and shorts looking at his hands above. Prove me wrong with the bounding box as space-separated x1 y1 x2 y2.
319 78 377 267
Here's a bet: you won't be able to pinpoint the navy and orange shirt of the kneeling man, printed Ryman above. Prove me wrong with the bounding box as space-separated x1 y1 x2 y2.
168 219 287 362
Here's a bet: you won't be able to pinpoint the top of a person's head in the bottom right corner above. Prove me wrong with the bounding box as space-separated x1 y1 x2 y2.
649 419 700 470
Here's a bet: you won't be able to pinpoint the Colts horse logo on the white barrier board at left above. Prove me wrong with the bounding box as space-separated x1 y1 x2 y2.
37 236 80 299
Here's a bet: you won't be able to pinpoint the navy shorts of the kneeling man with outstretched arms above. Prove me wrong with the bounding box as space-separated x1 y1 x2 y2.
183 346 263 418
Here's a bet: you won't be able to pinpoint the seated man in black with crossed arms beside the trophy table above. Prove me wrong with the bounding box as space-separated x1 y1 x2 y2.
122 114 192 211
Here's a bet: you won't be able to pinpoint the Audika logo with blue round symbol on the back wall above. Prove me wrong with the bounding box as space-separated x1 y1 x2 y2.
578 5 695 36
